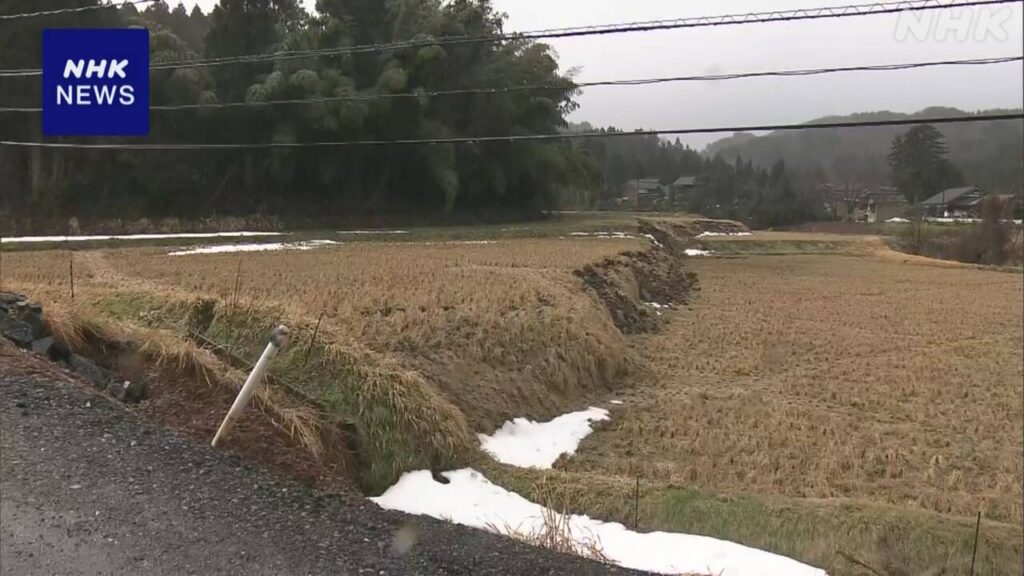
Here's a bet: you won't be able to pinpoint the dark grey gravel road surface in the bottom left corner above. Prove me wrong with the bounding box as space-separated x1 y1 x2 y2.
0 344 631 576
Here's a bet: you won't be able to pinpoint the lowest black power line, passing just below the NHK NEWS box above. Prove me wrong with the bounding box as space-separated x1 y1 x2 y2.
0 112 1024 151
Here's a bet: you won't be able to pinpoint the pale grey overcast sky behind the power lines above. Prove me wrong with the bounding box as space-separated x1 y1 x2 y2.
178 0 1024 147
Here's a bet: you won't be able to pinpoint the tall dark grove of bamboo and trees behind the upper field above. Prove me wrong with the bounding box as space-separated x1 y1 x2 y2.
0 0 599 224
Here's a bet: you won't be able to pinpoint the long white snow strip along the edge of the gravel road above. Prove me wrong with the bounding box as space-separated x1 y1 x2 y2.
371 468 825 576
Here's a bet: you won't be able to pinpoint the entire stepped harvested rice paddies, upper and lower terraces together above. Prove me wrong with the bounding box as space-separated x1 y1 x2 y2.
0 215 1024 576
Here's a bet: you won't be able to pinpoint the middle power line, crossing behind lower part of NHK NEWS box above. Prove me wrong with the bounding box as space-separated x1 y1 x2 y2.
0 55 1024 113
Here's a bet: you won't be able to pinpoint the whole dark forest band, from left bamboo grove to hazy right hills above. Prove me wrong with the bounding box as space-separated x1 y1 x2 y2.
0 0 1024 229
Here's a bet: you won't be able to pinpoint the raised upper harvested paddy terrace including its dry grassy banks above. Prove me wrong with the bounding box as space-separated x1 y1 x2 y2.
2 230 688 492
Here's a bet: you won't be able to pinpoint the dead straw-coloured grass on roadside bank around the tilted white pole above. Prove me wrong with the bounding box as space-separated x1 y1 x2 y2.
9 302 353 489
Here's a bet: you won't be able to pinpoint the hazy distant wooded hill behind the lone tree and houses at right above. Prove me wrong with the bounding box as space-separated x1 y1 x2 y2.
706 108 1024 194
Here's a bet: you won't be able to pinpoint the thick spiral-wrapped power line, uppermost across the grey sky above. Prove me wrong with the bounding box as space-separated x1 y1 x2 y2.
0 0 1022 77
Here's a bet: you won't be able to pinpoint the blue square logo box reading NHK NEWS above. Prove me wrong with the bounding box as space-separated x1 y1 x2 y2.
43 28 150 136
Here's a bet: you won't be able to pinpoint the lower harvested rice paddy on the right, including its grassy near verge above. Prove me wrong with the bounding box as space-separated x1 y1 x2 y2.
562 243 1024 574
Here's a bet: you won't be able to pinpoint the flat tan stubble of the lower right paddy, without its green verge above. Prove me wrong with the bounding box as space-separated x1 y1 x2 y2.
570 256 1024 525
